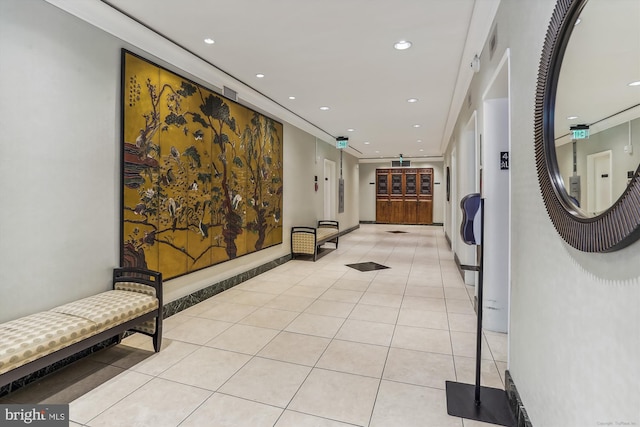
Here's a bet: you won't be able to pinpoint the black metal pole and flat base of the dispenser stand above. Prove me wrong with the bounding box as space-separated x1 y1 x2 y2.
446 199 516 427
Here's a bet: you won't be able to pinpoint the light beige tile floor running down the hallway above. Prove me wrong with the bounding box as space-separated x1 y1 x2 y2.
0 224 507 427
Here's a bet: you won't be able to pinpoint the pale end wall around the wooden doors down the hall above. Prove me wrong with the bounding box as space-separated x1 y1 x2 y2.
359 159 446 223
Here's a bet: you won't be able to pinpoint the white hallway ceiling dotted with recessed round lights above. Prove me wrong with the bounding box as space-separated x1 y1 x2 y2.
47 0 499 160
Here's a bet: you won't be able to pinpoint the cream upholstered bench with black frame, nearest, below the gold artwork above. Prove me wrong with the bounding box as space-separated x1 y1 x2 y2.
0 268 162 392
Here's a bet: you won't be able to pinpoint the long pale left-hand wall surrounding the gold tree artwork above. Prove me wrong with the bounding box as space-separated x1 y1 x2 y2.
0 0 359 322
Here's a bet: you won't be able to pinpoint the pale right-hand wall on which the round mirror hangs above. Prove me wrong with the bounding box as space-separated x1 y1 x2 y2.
446 0 640 427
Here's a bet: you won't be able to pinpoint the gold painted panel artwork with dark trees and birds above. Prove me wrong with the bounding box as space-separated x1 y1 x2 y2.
121 50 282 278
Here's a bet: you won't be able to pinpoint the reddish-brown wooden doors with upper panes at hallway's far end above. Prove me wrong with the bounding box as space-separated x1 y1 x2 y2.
376 168 433 224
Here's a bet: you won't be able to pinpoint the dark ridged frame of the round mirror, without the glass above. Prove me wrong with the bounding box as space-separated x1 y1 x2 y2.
534 0 640 252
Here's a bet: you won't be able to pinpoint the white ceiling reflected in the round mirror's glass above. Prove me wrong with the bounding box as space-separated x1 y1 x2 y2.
554 0 640 145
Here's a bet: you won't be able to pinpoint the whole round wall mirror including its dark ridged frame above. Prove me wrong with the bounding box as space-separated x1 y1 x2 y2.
535 0 640 252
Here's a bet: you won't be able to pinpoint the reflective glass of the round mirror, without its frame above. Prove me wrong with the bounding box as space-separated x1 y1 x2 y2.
554 0 640 217
